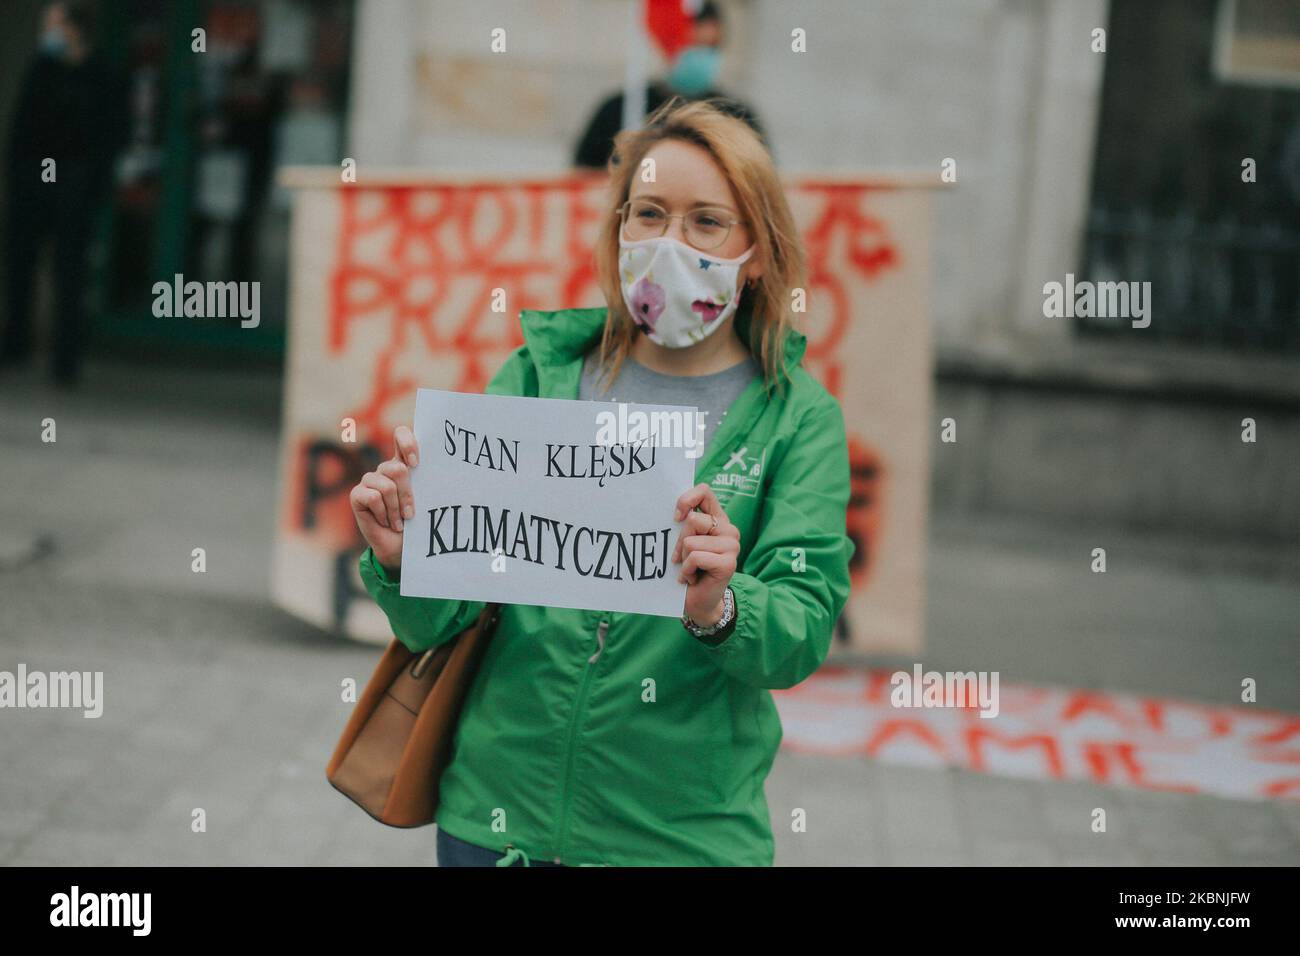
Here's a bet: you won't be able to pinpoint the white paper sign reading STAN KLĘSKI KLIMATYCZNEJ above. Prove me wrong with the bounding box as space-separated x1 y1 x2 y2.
402 389 699 617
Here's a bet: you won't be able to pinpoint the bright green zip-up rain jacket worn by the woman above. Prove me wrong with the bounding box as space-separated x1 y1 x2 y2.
360 308 854 866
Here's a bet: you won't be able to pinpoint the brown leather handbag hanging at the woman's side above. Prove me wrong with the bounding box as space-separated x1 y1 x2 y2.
325 604 501 827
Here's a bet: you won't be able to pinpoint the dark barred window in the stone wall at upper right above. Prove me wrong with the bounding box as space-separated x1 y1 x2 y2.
1075 0 1300 352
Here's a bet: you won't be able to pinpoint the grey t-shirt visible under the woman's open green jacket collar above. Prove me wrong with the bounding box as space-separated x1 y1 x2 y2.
577 351 762 457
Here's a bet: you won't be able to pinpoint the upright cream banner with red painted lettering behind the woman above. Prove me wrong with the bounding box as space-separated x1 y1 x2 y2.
272 169 935 653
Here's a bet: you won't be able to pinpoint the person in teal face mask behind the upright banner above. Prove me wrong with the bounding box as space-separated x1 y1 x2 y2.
573 0 764 169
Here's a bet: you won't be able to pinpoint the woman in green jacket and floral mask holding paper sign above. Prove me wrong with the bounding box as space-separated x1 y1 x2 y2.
351 103 853 866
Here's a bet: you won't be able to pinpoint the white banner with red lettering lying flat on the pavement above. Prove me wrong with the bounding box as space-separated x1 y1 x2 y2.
774 667 1300 800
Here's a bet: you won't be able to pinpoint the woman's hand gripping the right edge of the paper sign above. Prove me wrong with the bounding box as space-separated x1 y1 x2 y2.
672 483 740 627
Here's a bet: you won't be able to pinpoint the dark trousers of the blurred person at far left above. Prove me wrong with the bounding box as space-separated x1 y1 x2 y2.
0 159 104 376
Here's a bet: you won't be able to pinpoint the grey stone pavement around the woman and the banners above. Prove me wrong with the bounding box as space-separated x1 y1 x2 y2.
0 364 1300 865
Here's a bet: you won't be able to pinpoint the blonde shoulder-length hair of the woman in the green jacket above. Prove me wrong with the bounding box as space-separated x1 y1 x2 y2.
595 96 805 392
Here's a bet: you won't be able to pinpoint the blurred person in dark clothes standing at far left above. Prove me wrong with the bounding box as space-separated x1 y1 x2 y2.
0 0 127 385
